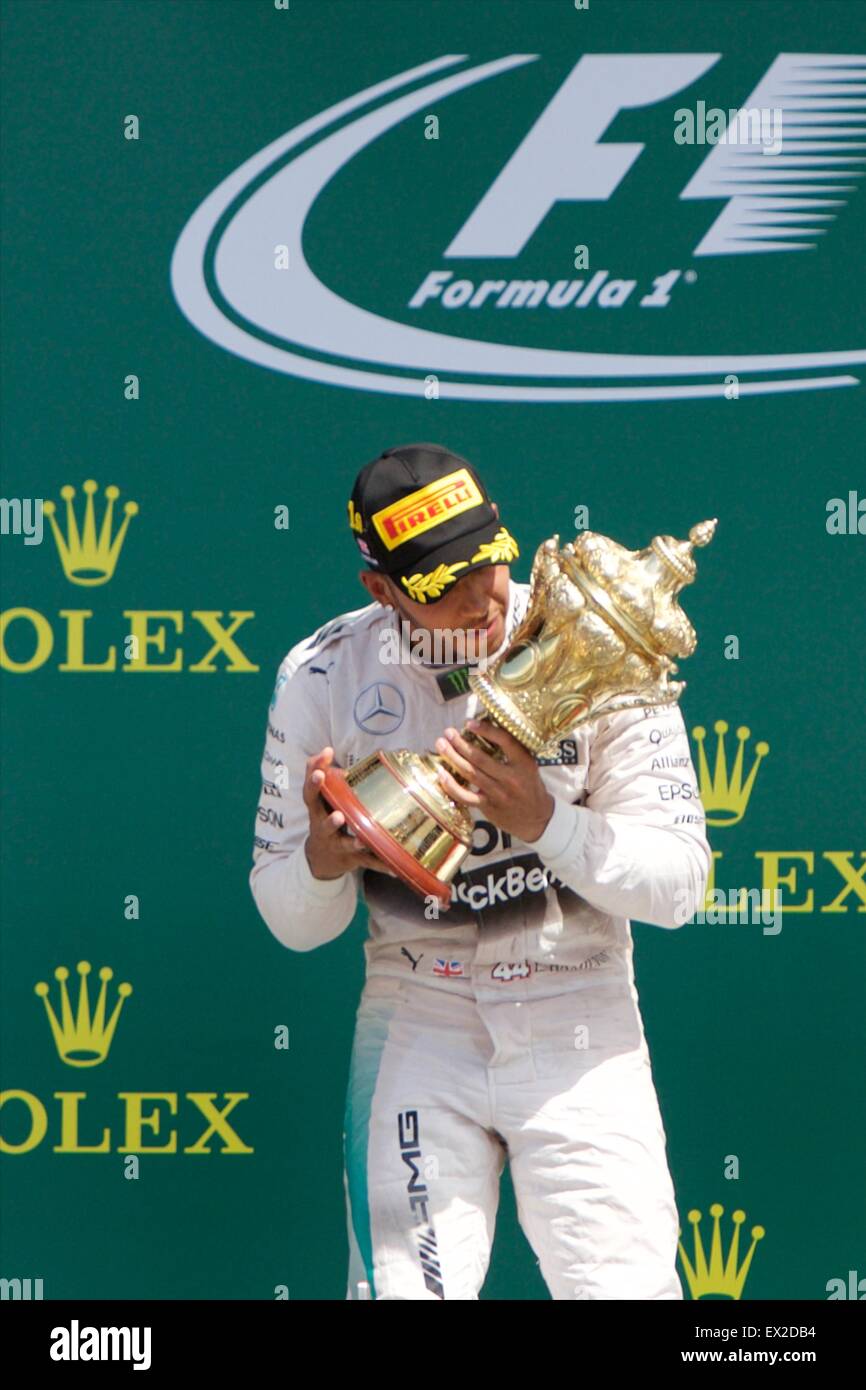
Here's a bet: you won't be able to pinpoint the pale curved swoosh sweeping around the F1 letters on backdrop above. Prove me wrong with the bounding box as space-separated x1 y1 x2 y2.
171 54 866 402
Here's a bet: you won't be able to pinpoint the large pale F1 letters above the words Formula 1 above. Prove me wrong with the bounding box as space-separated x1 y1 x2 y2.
445 53 866 259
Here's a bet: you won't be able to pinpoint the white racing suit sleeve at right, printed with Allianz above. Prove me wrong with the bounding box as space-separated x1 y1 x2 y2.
532 705 712 927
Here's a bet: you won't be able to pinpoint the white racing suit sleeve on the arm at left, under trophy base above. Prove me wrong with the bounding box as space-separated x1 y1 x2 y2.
249 657 360 951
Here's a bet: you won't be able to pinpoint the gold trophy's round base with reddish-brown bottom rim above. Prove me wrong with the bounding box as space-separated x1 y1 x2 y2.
320 749 473 908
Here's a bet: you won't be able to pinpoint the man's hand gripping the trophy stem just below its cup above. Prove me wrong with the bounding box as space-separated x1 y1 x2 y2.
436 719 555 844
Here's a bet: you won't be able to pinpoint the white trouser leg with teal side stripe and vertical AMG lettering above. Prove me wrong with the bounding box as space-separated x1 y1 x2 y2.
345 981 505 1298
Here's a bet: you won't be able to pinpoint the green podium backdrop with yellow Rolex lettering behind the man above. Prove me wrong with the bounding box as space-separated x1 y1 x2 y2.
0 0 866 1298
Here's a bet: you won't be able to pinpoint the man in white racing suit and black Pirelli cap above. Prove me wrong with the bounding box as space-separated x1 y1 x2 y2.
250 445 710 1300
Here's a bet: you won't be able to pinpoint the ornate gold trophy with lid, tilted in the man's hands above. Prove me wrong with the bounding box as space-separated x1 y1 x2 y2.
321 520 716 908
